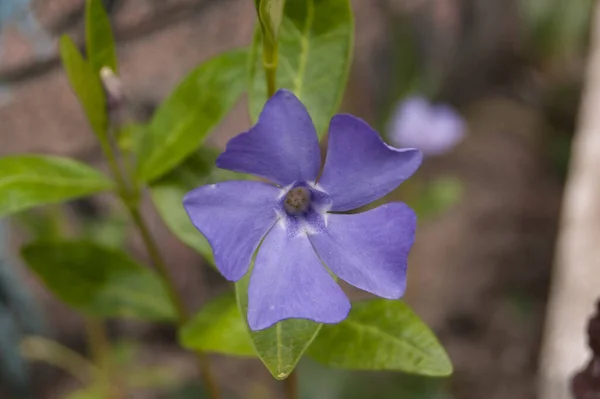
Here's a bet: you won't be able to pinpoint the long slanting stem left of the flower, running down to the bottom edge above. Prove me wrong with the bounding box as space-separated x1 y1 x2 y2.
103 138 220 399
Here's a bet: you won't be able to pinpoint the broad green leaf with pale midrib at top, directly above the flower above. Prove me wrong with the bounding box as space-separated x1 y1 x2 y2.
249 0 354 137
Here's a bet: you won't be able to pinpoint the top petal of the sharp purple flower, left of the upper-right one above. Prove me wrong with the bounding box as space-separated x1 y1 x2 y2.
217 90 321 186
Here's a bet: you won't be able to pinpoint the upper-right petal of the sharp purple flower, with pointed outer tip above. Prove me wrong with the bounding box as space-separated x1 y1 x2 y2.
319 115 423 212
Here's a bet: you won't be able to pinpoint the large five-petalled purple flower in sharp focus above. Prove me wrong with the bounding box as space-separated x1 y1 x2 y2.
183 90 422 330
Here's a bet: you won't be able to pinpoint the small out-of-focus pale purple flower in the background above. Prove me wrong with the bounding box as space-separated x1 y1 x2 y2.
389 97 466 155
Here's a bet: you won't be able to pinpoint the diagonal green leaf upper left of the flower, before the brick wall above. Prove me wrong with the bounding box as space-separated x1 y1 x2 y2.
137 50 247 182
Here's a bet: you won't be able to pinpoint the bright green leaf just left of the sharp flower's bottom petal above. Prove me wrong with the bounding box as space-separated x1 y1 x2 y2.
179 291 256 356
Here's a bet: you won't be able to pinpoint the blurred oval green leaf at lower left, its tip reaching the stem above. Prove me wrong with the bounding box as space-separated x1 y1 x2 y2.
22 241 175 321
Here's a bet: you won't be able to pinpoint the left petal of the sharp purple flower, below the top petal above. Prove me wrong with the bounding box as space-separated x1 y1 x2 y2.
183 181 282 281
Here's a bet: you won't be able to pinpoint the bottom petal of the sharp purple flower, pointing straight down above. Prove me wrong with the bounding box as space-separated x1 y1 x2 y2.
248 224 350 330
